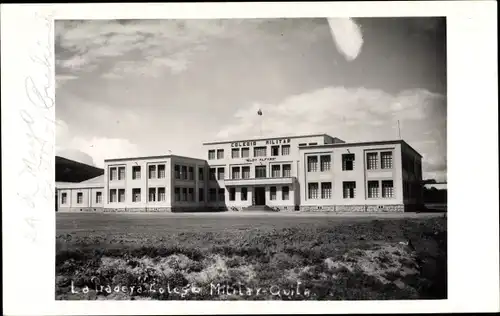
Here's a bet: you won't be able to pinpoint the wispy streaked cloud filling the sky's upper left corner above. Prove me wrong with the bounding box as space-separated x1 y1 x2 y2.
56 20 254 78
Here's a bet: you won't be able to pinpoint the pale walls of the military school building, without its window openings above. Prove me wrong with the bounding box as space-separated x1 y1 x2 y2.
54 135 422 212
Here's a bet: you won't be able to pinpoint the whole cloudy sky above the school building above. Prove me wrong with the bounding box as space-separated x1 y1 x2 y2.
55 17 447 181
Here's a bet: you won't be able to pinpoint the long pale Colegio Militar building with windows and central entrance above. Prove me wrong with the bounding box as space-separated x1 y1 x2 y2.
58 134 422 212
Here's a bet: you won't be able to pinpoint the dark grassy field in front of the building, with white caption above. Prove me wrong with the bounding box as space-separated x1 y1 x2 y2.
56 213 447 300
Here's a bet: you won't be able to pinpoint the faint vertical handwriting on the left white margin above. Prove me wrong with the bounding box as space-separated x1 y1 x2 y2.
17 14 55 242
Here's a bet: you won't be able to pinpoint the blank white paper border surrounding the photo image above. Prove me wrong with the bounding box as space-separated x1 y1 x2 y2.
1 1 500 315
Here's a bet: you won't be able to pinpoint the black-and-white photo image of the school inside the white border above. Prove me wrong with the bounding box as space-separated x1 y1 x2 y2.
55 17 447 300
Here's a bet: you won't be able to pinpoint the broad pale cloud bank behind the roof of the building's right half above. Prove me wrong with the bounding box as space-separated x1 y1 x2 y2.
216 87 446 176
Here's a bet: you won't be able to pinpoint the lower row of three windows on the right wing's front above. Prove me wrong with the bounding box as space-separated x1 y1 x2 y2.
308 180 394 199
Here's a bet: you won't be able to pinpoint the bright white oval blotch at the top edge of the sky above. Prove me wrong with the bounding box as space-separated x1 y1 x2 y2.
328 18 363 61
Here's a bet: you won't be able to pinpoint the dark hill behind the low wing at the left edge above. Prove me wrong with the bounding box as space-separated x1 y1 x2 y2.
56 156 104 182
